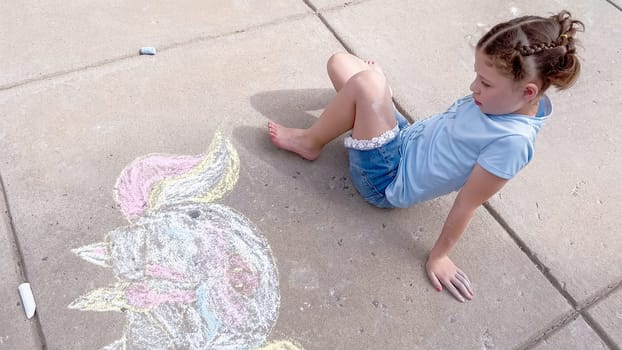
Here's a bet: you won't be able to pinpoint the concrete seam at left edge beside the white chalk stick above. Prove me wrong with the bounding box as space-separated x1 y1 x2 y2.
0 173 47 350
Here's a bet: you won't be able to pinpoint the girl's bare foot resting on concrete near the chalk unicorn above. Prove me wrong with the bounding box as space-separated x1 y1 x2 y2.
268 121 322 160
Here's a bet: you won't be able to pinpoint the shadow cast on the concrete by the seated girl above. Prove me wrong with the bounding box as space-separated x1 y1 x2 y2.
232 89 433 266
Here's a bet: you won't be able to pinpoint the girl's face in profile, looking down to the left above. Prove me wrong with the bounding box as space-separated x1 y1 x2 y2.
470 50 537 115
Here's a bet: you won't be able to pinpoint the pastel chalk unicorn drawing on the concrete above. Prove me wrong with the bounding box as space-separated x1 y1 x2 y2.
68 133 302 350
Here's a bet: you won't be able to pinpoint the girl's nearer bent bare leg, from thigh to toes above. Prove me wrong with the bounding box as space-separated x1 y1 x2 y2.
268 69 396 160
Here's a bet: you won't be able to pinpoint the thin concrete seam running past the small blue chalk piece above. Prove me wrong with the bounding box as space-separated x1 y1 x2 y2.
0 13 315 92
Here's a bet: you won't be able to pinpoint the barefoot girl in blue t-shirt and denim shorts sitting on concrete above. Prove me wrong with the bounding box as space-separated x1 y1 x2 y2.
268 11 584 302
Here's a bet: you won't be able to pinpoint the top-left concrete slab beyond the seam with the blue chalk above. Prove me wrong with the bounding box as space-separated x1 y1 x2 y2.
0 0 309 87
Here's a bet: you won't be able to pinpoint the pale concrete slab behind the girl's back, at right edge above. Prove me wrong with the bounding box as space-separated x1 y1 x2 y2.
492 2 622 304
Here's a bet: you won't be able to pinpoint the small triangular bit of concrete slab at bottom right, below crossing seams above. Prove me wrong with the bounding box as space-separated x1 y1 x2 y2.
534 317 609 350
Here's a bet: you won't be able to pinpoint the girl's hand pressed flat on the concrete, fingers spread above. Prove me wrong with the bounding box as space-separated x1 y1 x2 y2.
425 255 475 302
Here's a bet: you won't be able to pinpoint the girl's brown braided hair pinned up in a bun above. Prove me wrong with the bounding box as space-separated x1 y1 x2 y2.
477 10 585 93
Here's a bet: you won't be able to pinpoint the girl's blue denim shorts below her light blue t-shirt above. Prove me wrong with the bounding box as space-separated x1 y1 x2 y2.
348 110 409 208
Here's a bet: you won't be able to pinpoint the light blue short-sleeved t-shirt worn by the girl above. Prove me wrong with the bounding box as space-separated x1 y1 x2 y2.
385 95 553 208
